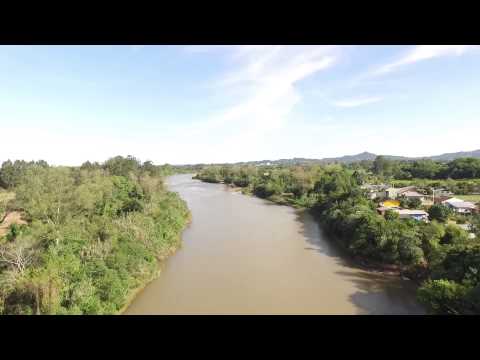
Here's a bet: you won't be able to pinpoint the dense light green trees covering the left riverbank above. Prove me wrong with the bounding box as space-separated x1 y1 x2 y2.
0 156 189 314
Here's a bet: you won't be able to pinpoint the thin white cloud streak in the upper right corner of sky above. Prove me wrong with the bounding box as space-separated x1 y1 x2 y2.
371 45 477 75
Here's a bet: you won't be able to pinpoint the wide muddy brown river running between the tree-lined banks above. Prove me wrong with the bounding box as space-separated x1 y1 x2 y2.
125 175 424 314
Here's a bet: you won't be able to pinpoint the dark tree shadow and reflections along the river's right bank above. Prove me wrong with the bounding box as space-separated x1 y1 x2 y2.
168 176 425 315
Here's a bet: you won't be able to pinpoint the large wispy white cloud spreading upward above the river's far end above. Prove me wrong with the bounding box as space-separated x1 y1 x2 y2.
172 45 341 161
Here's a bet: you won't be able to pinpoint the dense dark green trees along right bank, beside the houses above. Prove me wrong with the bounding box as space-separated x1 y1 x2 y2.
197 158 480 314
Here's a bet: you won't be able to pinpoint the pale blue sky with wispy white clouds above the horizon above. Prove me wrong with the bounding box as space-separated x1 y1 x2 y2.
0 45 480 165
